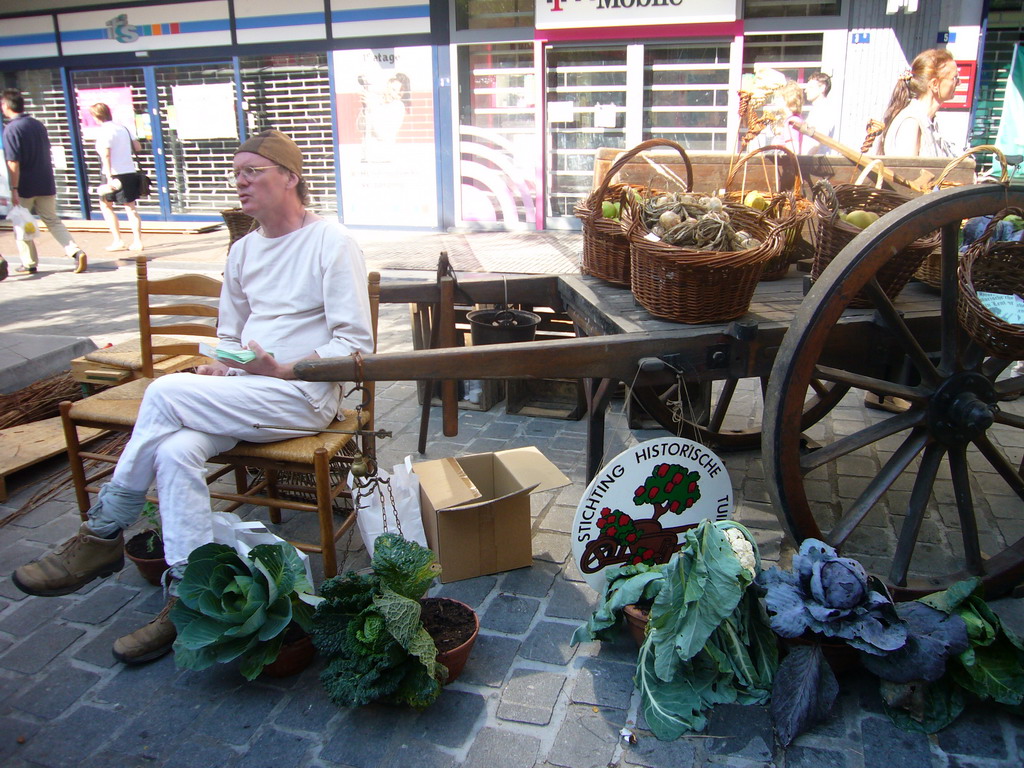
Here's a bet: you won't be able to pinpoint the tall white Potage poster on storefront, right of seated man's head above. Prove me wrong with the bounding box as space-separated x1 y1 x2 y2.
334 45 437 227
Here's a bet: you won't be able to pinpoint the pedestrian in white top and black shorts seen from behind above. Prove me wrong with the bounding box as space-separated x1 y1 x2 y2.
89 101 142 251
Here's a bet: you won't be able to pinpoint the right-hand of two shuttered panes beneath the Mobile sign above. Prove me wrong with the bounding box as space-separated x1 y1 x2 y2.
643 45 729 152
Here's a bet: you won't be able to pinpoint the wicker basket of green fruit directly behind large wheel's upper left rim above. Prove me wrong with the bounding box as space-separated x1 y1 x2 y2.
811 181 941 307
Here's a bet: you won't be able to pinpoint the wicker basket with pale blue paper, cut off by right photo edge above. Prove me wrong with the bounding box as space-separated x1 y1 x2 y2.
956 208 1024 360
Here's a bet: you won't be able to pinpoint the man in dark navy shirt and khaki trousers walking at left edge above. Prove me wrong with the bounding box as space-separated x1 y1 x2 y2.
0 88 88 274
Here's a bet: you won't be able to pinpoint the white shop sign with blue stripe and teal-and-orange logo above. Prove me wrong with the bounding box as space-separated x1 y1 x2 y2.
57 0 231 56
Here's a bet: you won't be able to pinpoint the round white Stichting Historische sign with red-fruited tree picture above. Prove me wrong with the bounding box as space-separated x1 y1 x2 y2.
572 437 735 592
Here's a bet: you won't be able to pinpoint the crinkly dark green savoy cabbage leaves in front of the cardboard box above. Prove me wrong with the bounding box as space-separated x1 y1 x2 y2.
311 534 447 709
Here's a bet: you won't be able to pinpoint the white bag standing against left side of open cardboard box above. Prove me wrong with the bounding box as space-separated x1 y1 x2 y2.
348 456 427 555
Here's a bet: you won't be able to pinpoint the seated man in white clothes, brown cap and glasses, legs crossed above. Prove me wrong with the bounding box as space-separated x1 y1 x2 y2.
13 130 373 664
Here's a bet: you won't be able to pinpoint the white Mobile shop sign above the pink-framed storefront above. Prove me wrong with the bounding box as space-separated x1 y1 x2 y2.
535 0 736 30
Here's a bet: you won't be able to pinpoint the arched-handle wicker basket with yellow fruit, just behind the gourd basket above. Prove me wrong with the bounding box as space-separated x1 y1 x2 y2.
725 145 814 281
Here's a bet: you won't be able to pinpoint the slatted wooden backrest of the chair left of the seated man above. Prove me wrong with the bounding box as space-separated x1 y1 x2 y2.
135 256 221 378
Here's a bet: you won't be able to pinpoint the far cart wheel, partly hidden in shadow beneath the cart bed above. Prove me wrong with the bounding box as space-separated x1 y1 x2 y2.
631 379 849 451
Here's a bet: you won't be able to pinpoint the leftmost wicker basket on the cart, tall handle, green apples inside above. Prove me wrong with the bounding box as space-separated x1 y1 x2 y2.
573 138 693 288
